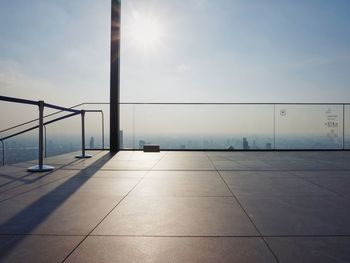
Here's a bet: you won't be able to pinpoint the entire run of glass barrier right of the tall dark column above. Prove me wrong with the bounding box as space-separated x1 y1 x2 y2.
121 103 350 150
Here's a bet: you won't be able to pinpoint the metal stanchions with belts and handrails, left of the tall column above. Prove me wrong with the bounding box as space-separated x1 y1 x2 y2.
0 96 104 172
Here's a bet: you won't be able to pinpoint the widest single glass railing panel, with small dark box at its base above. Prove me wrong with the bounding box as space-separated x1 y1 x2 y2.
134 104 274 150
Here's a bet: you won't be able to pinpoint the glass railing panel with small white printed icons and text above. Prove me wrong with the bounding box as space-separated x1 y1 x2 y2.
275 104 343 149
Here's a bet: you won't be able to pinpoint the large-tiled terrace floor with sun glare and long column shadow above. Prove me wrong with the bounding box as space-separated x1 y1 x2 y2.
0 152 350 263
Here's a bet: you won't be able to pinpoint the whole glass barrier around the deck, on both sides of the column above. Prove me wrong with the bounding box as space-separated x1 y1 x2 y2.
0 103 350 164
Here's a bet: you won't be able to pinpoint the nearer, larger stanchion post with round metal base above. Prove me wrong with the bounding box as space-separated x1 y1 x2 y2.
28 100 54 172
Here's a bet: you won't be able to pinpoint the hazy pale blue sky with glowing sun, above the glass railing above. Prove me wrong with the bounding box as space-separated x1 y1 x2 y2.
0 0 350 106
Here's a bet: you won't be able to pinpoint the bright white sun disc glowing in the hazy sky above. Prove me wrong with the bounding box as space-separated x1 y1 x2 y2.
128 13 163 51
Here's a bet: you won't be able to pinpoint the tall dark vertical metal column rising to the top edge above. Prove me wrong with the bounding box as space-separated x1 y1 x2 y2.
109 0 121 152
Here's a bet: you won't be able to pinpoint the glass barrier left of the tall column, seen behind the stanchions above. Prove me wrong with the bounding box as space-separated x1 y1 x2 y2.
0 103 109 165
